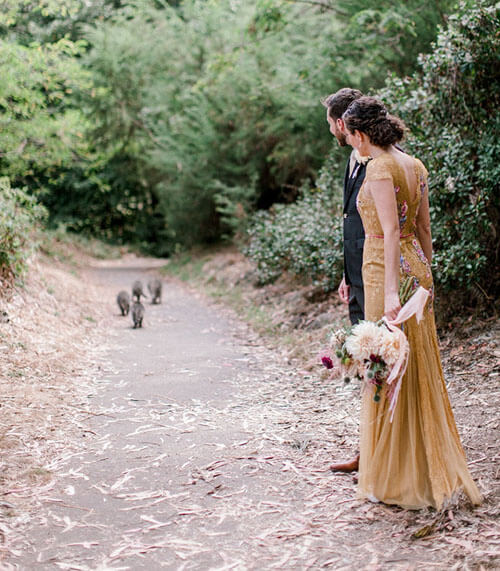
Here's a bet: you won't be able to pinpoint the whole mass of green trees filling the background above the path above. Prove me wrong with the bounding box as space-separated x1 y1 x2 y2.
0 0 460 253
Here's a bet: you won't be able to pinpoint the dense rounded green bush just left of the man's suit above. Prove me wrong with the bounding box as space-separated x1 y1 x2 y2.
244 189 343 290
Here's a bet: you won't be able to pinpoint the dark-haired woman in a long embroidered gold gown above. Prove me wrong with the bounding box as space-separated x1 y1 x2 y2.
342 97 481 509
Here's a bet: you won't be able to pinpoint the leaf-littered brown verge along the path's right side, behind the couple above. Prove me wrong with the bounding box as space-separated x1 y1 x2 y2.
165 250 500 569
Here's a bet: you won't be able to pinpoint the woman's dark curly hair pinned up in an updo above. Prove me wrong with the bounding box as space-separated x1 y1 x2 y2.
342 96 406 148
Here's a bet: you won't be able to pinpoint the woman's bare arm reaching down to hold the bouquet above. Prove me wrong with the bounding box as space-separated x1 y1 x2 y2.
367 179 401 319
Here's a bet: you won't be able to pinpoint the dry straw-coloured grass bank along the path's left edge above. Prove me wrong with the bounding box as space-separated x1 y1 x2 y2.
0 252 111 560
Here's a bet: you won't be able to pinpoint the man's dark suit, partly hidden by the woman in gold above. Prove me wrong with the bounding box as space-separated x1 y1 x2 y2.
343 155 366 324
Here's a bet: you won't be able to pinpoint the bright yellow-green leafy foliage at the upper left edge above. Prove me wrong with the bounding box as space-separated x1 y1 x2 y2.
0 38 90 190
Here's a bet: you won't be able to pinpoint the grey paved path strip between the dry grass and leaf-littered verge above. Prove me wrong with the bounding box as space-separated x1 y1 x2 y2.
17 264 332 569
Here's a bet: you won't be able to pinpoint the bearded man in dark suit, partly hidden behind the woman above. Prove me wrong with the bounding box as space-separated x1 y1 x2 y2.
323 87 368 472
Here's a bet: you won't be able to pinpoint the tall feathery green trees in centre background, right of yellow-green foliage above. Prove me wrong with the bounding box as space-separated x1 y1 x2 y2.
81 0 453 251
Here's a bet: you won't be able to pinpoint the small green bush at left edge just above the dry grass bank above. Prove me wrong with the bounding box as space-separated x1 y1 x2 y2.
0 177 47 282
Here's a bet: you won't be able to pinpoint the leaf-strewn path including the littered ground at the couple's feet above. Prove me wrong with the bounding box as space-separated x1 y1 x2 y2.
4 258 500 570
